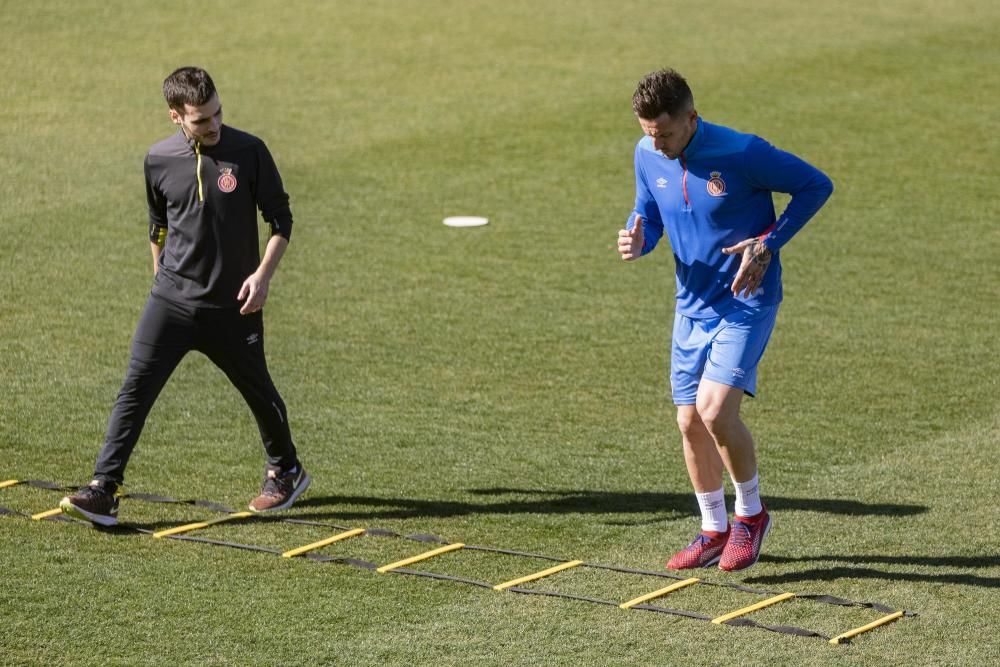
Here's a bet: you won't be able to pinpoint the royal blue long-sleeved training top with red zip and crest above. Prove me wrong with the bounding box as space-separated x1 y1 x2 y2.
627 118 833 319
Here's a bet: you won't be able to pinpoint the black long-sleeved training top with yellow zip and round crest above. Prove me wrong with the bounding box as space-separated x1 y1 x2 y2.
144 125 292 308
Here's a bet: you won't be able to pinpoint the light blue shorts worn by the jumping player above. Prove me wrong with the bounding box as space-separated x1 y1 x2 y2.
670 305 778 405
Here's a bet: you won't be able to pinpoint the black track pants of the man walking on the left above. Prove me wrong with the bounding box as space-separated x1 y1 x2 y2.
94 295 298 483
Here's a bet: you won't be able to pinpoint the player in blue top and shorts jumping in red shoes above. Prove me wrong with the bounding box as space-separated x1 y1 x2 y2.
618 69 833 571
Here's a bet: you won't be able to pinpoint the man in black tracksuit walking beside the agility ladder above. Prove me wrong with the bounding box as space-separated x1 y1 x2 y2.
60 67 310 526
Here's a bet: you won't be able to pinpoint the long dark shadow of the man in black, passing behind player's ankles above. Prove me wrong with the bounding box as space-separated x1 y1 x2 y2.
286 488 929 525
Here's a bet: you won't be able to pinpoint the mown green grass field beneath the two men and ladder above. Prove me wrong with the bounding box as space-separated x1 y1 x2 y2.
0 0 1000 667
